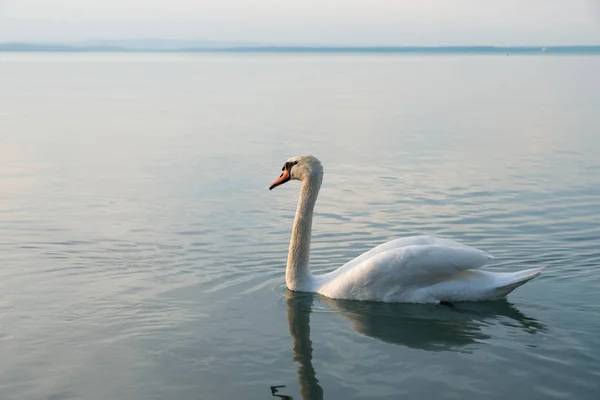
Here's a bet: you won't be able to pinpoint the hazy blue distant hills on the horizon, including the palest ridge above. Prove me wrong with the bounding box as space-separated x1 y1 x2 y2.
0 39 600 54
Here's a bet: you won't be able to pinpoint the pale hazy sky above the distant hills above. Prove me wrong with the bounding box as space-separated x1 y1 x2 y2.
0 0 600 45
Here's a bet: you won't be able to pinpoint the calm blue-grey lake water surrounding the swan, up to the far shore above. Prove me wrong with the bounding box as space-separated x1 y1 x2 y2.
0 54 600 400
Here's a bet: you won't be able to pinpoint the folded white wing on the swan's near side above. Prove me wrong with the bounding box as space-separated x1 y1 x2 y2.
330 244 492 291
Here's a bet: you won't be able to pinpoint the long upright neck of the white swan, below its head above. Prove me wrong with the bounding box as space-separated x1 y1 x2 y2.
285 176 322 291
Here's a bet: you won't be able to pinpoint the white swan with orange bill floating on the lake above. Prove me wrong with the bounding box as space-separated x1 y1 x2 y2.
269 156 544 303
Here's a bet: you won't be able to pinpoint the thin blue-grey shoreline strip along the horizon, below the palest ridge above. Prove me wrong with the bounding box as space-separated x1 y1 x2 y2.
0 42 600 54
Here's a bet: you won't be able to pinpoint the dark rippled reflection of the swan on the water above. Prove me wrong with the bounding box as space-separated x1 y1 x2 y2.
286 290 546 400
